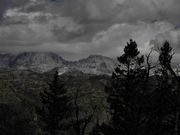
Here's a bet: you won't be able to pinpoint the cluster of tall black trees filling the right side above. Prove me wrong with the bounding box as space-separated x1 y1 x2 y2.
93 40 180 135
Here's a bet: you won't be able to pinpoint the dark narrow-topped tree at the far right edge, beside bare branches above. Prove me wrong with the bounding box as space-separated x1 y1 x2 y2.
147 42 180 135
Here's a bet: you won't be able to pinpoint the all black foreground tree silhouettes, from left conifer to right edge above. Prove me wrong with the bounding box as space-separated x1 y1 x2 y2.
37 40 180 135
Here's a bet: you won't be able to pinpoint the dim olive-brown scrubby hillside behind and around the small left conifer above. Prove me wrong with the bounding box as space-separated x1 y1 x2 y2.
0 70 110 135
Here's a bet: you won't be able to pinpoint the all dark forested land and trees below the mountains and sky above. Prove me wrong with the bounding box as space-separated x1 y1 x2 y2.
0 40 180 135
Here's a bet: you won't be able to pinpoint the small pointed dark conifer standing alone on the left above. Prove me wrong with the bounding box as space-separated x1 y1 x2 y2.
39 72 69 135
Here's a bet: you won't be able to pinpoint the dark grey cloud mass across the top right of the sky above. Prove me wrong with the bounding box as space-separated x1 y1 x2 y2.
28 0 180 41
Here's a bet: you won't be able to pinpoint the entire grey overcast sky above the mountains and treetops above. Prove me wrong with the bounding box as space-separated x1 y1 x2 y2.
0 0 180 59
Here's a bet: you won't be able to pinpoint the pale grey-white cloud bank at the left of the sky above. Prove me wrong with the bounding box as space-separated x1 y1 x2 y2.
0 12 82 46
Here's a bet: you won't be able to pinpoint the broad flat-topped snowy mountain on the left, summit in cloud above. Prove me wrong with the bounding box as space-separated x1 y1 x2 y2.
10 52 64 72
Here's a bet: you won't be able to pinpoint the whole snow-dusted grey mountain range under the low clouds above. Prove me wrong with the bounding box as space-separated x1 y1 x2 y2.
0 52 116 75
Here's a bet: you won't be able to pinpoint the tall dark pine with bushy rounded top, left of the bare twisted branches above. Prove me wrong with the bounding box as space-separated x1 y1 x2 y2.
108 40 146 135
